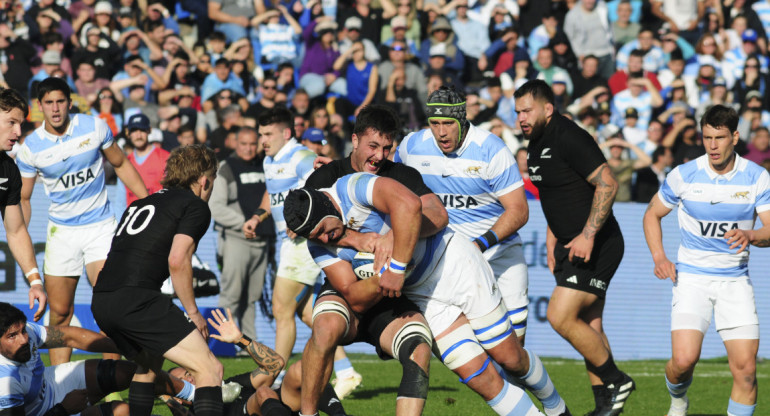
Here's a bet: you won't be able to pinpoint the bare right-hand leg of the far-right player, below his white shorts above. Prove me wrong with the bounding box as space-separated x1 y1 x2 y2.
725 339 759 405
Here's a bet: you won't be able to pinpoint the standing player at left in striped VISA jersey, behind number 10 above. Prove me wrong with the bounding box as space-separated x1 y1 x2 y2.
16 78 147 365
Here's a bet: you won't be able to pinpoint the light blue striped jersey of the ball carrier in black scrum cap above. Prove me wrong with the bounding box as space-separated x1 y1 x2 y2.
308 172 453 286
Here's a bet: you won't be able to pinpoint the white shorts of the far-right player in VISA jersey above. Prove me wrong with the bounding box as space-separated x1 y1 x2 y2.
671 276 759 341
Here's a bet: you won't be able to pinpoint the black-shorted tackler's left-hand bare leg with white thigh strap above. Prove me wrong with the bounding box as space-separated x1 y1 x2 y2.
300 296 357 415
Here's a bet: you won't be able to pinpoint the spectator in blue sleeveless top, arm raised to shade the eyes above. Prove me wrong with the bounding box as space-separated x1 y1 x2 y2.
334 41 379 115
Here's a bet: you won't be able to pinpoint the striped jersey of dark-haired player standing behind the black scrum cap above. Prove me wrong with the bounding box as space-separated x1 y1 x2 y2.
262 138 316 239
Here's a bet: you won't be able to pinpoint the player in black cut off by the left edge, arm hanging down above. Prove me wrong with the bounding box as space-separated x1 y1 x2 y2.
0 88 47 321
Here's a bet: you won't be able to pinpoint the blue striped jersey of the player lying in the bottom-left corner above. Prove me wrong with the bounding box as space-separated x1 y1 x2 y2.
0 322 47 415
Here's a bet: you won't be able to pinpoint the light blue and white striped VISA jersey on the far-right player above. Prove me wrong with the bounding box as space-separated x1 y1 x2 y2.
658 155 770 278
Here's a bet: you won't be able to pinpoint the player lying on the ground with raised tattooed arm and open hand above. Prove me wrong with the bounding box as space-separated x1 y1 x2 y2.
163 309 345 416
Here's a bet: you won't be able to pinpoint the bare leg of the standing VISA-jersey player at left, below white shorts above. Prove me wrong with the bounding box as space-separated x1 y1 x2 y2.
44 274 79 365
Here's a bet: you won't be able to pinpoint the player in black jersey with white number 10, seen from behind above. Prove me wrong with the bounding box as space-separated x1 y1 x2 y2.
91 145 222 416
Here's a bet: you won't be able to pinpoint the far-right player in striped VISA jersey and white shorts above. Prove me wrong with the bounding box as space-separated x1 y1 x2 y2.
644 105 770 416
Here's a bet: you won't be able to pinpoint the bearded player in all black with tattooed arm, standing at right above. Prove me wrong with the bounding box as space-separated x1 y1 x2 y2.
514 80 635 416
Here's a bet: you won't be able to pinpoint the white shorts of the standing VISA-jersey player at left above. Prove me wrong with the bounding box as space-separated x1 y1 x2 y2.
43 218 117 277
